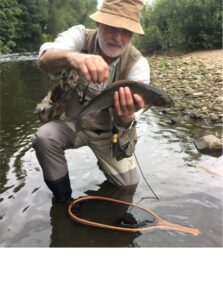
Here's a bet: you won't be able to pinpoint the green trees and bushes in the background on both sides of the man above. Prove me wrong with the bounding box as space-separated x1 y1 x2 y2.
0 0 222 53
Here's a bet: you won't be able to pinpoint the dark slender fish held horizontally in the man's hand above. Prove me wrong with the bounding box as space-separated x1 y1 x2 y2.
69 80 174 128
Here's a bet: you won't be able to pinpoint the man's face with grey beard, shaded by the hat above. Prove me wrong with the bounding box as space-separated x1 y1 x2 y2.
98 24 132 58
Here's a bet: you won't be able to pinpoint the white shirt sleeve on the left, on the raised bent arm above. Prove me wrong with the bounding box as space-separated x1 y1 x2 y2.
39 25 85 57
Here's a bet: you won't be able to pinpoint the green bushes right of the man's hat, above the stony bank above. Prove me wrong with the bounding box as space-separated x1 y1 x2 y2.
136 0 222 53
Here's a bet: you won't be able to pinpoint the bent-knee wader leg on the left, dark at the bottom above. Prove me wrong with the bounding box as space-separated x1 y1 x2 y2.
32 121 75 201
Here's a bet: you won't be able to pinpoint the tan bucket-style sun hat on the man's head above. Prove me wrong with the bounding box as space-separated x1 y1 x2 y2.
90 0 144 34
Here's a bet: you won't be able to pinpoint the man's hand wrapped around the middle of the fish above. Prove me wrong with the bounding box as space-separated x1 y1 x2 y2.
114 86 145 127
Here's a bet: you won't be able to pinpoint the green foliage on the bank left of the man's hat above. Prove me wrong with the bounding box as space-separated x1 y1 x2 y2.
0 0 97 53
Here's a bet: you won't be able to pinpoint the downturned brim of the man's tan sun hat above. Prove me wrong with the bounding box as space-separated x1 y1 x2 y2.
89 11 144 34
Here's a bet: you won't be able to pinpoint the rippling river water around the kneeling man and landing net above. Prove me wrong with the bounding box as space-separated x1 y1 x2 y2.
0 54 223 247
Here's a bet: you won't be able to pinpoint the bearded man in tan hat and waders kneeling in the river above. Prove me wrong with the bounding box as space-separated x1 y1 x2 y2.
33 0 149 201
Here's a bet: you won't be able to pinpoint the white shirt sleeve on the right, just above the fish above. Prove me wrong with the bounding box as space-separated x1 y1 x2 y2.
127 56 150 84
